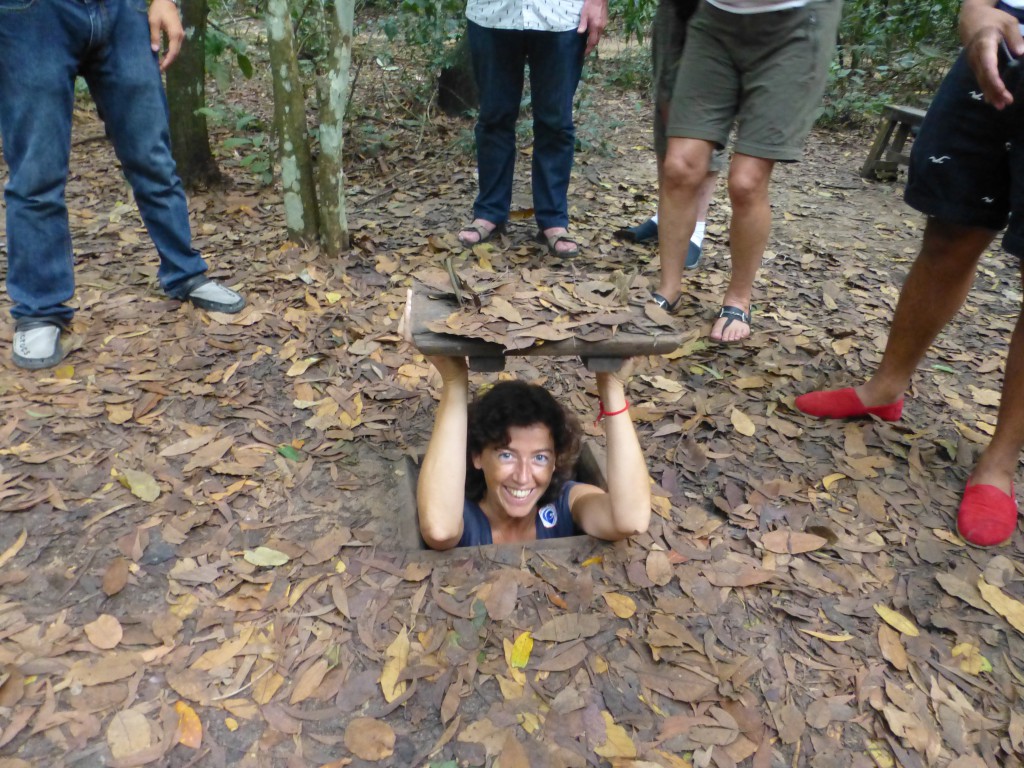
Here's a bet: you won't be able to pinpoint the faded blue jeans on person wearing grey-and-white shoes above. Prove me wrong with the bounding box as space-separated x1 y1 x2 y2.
0 0 206 323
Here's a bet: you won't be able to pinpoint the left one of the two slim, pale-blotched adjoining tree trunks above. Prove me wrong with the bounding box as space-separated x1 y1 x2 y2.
266 0 318 244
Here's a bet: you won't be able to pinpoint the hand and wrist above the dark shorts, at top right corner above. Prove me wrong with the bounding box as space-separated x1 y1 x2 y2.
959 0 1024 110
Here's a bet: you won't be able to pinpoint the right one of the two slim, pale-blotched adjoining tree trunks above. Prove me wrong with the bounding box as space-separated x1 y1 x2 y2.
317 0 355 257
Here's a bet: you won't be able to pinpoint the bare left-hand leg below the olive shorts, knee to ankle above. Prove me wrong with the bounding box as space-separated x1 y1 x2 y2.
657 137 714 302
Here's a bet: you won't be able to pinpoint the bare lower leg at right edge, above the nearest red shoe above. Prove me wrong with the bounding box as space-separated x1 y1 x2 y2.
971 263 1024 494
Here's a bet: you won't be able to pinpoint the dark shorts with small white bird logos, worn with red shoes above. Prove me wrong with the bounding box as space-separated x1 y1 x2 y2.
905 53 1024 258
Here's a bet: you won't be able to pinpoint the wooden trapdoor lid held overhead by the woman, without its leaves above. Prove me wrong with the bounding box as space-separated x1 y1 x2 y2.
411 288 682 362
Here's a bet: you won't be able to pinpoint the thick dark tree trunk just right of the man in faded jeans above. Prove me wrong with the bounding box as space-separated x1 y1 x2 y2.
167 0 224 190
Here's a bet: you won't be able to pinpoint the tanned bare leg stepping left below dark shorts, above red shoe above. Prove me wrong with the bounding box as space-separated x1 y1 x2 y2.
856 218 999 405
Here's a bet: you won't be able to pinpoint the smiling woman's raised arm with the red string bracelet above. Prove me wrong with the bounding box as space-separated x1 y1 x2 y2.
569 360 650 541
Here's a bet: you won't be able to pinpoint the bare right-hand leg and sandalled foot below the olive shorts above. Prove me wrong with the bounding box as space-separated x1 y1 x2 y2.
711 155 775 341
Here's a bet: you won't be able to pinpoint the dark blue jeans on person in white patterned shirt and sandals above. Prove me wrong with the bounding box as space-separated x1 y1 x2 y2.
466 20 587 229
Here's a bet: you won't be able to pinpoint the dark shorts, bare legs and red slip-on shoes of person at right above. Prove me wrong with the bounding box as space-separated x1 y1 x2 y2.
797 49 1024 546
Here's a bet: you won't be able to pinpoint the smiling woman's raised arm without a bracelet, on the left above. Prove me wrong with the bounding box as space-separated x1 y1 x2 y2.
416 357 469 549
